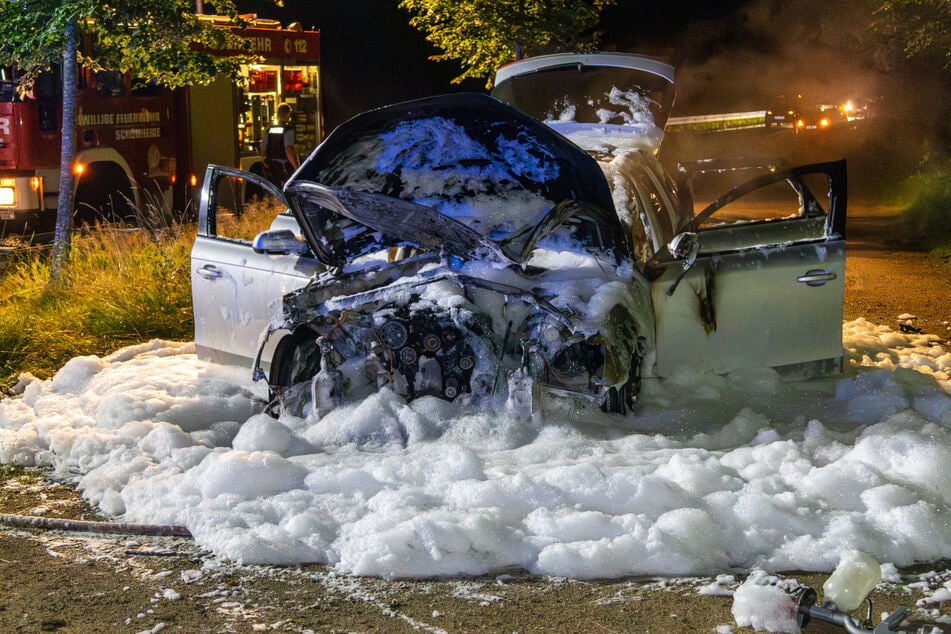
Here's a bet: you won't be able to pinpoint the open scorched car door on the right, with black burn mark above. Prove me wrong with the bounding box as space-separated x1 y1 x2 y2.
649 161 846 378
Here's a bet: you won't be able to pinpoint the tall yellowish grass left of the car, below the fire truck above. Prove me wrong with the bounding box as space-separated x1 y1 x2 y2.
0 225 194 389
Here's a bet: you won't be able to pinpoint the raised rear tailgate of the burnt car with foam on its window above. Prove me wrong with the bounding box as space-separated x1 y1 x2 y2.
492 53 674 154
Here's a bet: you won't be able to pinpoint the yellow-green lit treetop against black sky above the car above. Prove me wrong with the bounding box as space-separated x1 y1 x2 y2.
399 0 614 85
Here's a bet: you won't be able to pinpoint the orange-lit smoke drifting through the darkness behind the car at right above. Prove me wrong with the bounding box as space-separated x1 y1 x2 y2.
650 0 951 196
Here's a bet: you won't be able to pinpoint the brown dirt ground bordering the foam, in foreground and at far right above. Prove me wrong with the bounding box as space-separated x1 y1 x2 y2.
0 207 951 633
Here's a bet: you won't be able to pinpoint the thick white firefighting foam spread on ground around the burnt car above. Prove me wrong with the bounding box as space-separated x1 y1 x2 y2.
0 320 951 580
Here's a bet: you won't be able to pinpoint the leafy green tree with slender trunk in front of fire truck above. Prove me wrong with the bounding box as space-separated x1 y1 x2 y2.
0 0 249 283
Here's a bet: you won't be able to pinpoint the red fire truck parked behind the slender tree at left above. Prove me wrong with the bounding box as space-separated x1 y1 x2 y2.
0 16 323 234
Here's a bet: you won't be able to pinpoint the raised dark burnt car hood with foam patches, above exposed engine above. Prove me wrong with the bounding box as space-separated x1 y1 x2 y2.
285 94 623 267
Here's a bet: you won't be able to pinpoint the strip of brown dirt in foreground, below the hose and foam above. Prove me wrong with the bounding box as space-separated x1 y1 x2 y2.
0 494 951 633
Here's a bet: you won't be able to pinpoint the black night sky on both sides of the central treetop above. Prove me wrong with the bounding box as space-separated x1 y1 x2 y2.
239 0 760 128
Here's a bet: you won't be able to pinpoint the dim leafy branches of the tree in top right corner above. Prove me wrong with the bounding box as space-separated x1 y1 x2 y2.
876 0 951 71
